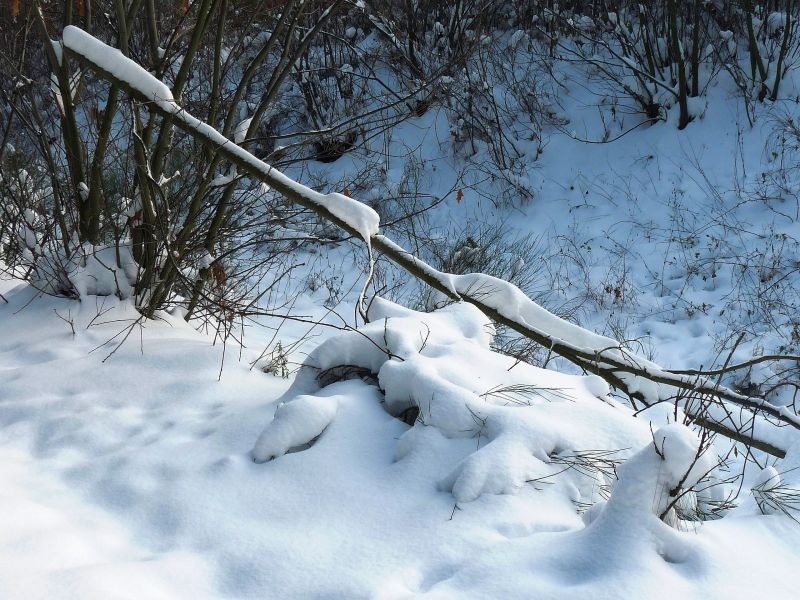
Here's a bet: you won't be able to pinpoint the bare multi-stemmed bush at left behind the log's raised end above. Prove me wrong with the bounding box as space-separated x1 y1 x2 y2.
0 1 362 323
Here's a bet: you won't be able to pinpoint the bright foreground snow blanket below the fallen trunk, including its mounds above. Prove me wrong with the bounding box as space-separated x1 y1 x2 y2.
0 282 800 600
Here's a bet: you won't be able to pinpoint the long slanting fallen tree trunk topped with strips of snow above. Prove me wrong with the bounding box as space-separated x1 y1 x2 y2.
63 26 800 457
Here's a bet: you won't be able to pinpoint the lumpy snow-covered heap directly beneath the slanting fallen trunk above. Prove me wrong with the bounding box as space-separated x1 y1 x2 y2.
252 299 656 504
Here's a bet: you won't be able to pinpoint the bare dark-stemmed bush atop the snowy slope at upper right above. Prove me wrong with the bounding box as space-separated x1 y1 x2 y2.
516 0 798 129
